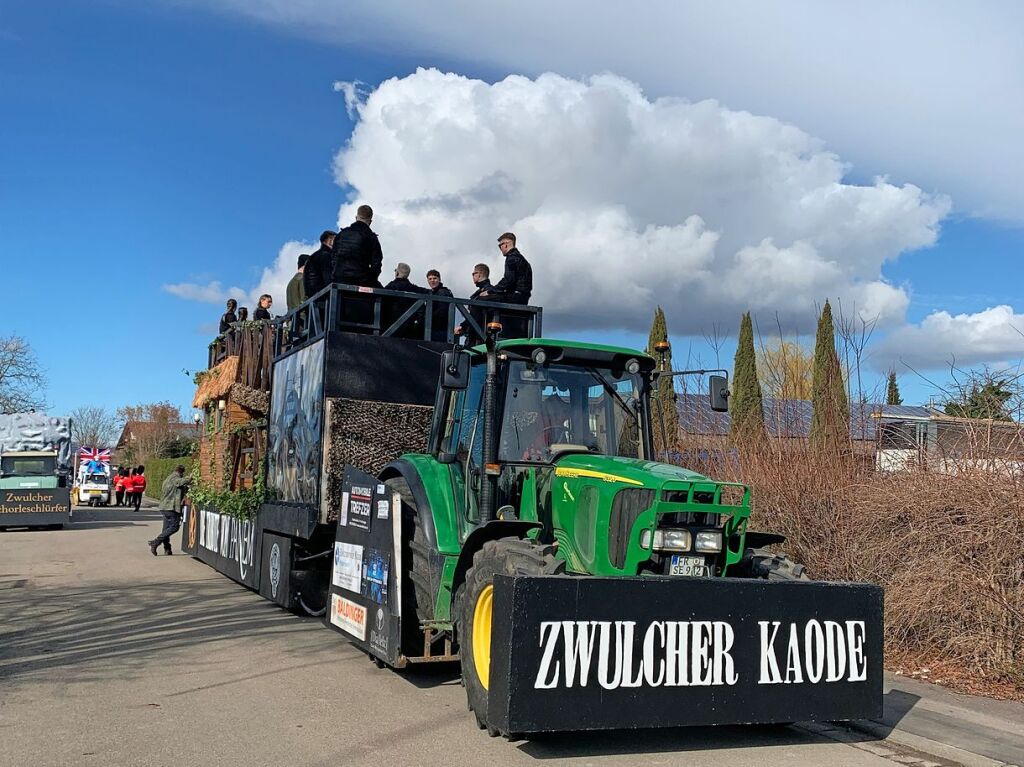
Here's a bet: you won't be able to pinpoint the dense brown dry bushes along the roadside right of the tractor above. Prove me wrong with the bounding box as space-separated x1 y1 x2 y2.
701 443 1024 693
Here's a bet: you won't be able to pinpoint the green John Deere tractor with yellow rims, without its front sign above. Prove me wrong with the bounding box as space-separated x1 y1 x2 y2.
381 327 807 729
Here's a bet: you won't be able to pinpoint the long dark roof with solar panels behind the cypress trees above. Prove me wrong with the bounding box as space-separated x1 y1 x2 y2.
676 394 932 441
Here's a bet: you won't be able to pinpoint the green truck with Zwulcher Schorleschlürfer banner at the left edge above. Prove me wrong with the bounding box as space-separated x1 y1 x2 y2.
0 413 72 529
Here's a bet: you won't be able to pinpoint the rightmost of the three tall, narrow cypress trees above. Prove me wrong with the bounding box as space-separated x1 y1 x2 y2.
810 301 850 453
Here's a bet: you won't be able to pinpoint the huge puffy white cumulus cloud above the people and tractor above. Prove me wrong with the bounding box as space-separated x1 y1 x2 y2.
335 70 949 333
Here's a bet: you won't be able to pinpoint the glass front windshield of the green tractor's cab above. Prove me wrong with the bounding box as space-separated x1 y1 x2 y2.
498 361 643 463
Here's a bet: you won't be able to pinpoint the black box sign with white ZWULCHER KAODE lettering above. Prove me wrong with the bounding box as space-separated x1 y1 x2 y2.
487 576 883 732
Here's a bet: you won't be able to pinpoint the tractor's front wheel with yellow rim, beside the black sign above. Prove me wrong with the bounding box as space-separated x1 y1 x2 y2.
456 538 565 736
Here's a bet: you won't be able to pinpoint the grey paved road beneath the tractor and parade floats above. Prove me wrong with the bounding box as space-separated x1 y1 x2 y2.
0 509 1024 767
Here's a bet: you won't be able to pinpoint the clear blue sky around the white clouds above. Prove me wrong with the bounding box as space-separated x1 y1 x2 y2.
0 0 1024 421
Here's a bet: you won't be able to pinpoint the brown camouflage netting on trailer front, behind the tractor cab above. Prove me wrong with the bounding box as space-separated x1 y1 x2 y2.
325 398 434 521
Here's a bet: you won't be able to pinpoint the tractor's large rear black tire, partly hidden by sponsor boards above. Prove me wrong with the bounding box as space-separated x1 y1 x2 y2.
384 476 440 655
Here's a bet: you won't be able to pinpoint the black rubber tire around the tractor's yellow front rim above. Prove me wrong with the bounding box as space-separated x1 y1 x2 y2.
455 538 565 736
